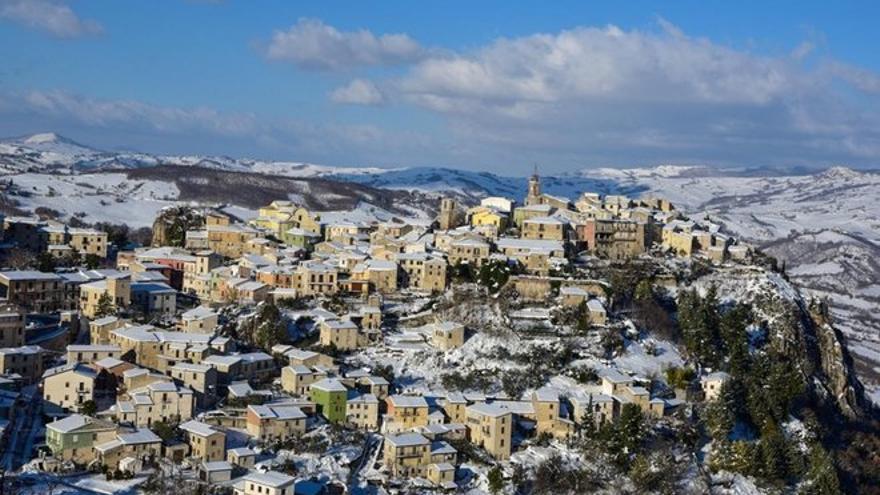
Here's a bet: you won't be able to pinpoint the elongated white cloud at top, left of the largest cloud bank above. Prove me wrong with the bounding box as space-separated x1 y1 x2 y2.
266 19 424 70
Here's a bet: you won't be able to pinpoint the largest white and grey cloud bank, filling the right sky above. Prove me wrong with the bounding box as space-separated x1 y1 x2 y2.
383 19 880 168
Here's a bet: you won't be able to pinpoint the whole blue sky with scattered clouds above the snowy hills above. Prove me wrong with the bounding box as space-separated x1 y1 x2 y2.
0 0 880 174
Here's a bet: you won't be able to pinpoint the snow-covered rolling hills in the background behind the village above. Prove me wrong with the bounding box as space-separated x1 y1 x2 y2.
0 133 880 400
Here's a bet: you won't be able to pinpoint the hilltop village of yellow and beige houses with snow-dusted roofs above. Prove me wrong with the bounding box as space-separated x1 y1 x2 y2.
0 170 792 495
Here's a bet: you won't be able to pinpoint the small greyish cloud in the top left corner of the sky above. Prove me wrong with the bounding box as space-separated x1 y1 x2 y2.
0 0 103 38
